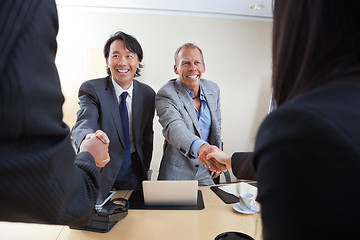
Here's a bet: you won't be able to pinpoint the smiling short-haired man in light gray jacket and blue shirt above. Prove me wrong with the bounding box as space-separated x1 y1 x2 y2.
155 43 222 185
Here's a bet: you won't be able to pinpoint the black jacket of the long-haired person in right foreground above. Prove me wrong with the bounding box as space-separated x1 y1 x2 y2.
254 78 360 240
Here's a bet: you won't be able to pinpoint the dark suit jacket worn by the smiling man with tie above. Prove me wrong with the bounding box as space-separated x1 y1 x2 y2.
72 76 155 199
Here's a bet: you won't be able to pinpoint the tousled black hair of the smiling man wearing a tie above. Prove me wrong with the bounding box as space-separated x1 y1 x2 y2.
104 31 143 77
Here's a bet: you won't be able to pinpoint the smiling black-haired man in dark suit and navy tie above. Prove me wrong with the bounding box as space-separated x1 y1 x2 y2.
72 32 155 201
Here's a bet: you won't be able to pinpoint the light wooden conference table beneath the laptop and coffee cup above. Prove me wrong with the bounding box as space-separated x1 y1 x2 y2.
0 186 263 240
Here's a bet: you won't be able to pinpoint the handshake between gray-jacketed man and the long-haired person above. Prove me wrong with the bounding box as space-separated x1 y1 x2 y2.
198 143 231 175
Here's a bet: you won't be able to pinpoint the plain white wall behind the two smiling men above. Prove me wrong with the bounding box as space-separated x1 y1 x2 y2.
56 6 271 181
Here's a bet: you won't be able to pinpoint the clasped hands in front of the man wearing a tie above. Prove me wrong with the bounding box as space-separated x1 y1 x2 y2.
80 130 110 167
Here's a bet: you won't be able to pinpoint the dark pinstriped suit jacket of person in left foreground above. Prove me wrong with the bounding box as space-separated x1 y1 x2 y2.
0 0 99 226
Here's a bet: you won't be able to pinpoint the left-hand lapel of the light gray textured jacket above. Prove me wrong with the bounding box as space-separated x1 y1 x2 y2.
175 79 201 137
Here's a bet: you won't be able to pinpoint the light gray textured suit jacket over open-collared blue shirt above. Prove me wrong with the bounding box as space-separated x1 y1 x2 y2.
155 79 222 185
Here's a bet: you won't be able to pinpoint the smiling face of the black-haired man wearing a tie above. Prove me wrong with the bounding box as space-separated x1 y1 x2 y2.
106 40 140 90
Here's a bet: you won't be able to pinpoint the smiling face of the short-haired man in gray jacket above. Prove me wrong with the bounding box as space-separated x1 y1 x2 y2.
174 47 205 95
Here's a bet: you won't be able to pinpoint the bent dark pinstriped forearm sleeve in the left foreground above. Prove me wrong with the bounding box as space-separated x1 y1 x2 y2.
0 135 99 225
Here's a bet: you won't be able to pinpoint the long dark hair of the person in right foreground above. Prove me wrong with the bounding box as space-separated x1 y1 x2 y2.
272 0 360 106
